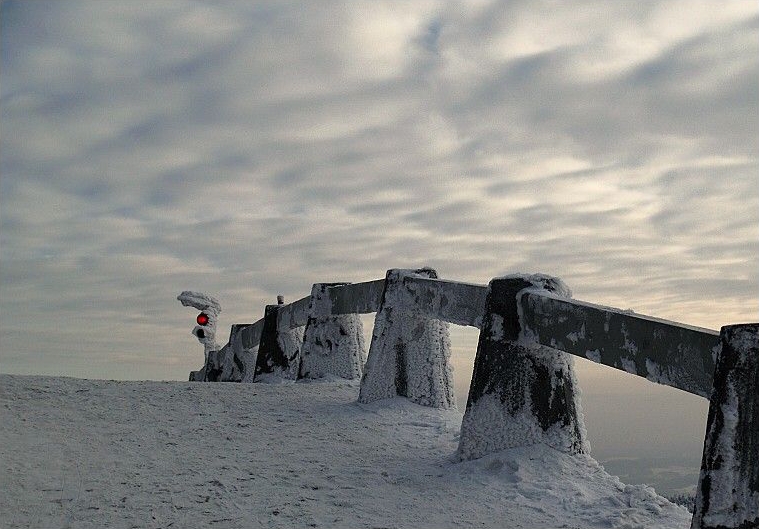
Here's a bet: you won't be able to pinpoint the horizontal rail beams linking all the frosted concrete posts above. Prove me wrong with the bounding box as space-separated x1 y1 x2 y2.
240 276 719 398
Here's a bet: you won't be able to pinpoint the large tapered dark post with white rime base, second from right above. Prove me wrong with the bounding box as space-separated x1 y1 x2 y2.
458 275 590 460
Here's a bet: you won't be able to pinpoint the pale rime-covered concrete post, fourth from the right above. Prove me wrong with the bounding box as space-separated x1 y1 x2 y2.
298 283 366 379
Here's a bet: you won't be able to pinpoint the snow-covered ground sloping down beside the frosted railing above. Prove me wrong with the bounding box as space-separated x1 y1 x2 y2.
0 375 690 529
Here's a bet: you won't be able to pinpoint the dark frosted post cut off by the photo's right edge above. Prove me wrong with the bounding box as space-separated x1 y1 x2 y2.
691 323 759 529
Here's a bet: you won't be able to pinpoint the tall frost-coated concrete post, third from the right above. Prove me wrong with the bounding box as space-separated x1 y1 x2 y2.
359 268 456 408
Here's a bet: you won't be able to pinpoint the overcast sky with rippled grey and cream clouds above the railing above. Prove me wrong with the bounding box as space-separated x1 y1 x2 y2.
0 0 759 379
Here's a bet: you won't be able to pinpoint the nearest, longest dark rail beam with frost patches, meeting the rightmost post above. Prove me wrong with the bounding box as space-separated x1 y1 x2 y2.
519 292 719 398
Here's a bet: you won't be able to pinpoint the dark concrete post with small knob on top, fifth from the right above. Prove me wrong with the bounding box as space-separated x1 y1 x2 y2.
255 305 303 380
